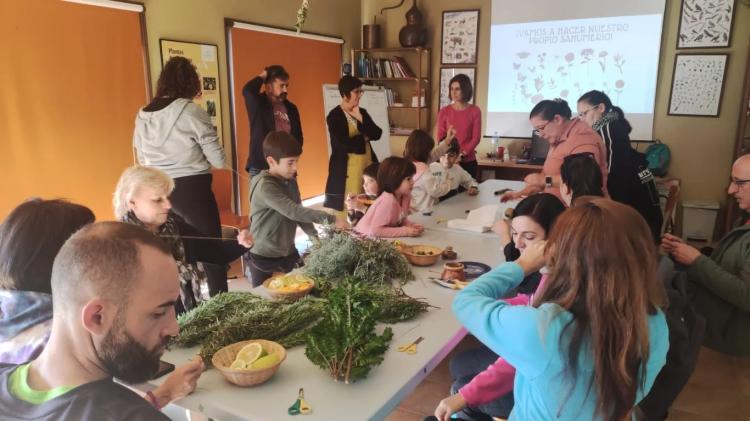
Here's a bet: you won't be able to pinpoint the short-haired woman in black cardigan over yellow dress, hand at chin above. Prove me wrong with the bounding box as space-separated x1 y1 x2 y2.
323 75 383 212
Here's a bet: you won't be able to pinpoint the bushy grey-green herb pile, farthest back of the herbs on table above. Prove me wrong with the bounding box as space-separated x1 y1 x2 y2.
303 230 414 285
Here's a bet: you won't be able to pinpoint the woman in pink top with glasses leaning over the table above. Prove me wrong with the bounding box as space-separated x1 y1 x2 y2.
500 98 607 202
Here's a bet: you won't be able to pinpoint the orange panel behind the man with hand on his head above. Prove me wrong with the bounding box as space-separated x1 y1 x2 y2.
230 28 341 215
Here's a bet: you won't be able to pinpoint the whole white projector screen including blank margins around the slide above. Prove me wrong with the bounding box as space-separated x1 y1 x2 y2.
485 0 664 140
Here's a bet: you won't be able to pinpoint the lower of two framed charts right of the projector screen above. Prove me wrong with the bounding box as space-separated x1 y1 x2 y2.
668 54 729 117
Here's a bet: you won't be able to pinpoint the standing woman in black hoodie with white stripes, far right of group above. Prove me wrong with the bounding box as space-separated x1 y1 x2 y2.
578 91 663 242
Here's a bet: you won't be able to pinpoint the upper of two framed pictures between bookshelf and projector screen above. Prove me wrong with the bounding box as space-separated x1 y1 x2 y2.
440 9 479 64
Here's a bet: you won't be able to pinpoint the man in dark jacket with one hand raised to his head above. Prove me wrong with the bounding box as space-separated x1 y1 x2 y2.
247 64 302 176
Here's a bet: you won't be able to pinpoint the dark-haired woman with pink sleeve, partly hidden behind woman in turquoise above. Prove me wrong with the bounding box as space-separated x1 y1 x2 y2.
435 193 565 421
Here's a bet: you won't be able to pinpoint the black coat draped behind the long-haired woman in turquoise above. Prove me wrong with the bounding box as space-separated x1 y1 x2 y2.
638 257 706 421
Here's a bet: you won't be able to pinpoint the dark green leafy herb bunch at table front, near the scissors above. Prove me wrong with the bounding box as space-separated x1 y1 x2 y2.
305 278 400 384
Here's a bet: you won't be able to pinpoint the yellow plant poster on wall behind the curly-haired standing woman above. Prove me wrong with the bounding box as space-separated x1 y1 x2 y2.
159 38 223 139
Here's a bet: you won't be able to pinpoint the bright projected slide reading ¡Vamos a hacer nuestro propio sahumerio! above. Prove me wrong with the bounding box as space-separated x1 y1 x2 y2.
487 14 662 136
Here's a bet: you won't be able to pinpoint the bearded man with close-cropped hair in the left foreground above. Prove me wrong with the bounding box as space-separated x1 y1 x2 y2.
0 222 203 421
